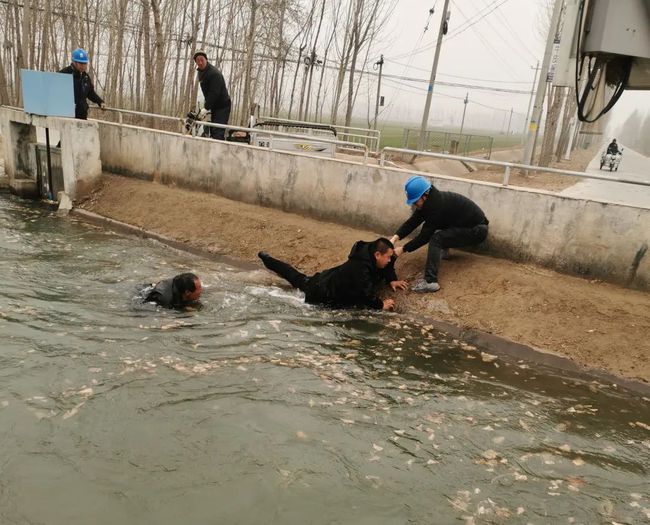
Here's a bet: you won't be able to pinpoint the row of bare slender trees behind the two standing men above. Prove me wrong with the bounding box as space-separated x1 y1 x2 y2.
0 0 397 125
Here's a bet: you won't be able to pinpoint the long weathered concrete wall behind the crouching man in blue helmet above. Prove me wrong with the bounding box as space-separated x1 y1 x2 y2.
99 123 650 290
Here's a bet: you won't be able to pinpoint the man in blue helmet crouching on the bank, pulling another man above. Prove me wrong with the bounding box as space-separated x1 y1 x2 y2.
390 176 488 292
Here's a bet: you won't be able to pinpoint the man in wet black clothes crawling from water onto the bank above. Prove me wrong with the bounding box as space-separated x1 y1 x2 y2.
257 237 406 310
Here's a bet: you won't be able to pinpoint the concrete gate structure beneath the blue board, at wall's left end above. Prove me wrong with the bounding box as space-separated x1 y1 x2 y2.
0 108 102 199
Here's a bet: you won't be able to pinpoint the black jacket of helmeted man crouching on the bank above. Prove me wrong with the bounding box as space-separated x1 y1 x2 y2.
395 187 488 252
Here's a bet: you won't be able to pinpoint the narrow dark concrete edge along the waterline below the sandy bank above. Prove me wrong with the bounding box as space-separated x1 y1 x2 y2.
71 208 650 397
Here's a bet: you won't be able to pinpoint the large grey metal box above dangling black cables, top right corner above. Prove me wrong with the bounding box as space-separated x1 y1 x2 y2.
582 0 650 58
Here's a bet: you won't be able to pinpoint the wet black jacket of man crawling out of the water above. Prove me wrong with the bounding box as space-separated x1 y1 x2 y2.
305 241 397 310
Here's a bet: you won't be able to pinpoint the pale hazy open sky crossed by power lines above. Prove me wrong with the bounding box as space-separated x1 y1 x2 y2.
376 0 650 131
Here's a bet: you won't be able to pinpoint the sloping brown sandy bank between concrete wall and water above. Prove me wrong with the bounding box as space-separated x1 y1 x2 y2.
81 175 650 382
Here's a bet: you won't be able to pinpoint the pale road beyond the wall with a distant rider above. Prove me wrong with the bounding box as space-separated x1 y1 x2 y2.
560 146 650 208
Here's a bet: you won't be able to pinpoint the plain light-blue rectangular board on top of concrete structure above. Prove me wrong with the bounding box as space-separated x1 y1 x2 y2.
20 69 74 117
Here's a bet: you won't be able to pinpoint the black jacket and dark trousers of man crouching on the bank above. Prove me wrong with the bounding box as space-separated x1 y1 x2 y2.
395 187 489 283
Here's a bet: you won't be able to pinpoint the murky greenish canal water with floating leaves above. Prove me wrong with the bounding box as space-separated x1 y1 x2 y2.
0 195 650 525
